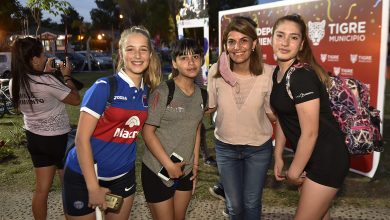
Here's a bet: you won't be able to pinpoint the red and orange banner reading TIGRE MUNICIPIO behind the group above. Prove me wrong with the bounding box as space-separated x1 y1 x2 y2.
219 0 389 177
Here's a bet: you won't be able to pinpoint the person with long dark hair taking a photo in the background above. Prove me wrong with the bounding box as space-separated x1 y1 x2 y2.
10 37 80 219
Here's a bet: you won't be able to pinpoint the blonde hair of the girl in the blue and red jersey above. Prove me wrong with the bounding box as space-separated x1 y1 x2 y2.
117 26 162 90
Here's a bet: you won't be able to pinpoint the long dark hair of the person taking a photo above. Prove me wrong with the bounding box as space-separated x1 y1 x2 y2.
11 37 44 108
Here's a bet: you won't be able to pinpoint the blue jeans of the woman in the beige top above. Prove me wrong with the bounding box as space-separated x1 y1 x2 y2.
215 140 273 220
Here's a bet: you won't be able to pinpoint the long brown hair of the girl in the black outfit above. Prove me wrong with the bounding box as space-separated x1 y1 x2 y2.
272 14 329 86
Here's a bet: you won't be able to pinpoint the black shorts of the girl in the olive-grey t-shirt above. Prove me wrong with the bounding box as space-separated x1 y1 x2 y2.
141 163 193 203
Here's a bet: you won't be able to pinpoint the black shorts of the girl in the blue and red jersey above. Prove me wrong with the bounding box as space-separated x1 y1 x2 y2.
62 167 136 216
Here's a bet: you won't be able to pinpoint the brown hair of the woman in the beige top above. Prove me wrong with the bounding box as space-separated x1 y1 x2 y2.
216 16 263 77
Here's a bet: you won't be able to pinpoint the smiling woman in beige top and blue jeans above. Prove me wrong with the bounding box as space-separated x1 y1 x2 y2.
208 16 274 220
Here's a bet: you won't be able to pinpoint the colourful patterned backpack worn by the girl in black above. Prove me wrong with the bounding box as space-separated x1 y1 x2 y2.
286 64 383 155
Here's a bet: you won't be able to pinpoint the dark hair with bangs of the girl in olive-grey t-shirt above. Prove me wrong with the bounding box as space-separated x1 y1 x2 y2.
171 38 203 77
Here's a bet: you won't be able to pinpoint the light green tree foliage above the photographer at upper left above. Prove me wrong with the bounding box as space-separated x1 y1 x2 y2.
27 0 70 36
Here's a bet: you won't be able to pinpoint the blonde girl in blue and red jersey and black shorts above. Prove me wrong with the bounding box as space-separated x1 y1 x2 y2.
63 26 161 219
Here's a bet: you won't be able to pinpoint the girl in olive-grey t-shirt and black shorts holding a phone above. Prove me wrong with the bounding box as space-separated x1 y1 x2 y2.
141 39 204 219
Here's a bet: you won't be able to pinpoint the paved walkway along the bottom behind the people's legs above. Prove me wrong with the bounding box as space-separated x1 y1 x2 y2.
0 190 390 220
